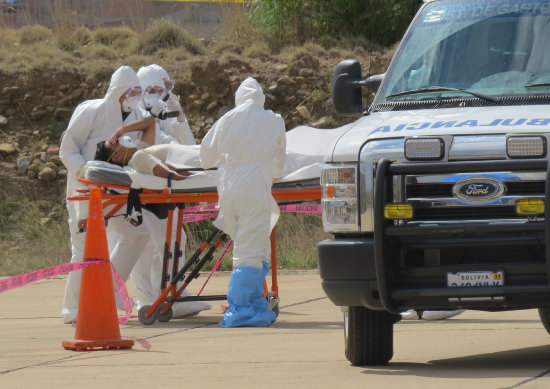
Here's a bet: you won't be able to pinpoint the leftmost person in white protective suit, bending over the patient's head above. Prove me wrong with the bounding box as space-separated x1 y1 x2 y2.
59 66 151 323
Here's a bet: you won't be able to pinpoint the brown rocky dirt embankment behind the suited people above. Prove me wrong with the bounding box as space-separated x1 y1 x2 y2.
0 53 387 199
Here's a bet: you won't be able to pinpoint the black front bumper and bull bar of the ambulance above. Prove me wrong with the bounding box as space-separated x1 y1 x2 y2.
319 160 550 313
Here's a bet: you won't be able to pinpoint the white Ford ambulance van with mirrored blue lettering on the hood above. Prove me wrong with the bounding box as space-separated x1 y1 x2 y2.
318 0 550 365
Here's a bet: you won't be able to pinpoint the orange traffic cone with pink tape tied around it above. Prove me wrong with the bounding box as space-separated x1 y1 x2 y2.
62 188 134 351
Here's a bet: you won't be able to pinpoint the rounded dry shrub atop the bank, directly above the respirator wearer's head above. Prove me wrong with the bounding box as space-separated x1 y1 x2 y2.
139 19 206 55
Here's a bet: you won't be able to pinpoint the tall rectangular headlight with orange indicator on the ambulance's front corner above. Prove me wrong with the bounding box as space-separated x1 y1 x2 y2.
321 165 359 232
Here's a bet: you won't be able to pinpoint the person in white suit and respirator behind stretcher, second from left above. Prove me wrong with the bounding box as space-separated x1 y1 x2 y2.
130 64 211 318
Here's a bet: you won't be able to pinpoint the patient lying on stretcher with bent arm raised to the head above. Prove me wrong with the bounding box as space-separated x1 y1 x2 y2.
94 118 189 181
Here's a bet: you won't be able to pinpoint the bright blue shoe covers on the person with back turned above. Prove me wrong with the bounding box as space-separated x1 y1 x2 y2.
220 262 277 327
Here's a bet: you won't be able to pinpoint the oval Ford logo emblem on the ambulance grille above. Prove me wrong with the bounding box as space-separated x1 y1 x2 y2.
453 177 506 203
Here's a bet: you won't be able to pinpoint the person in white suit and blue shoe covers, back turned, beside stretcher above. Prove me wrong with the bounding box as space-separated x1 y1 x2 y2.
200 78 286 327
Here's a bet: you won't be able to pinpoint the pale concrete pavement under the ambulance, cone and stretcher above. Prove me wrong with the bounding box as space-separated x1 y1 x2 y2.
0 272 550 389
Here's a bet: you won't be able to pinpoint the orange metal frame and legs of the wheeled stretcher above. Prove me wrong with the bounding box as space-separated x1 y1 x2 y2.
67 178 321 325
